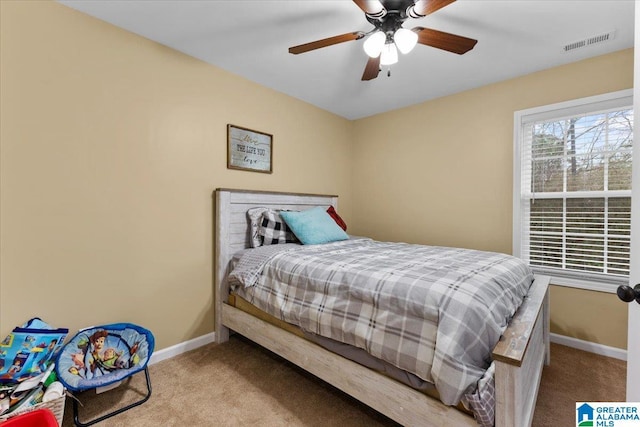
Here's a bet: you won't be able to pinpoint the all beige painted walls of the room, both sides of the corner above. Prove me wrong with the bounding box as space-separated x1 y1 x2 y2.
0 1 633 354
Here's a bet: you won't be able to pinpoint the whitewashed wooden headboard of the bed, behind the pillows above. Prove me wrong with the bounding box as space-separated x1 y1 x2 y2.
214 188 338 342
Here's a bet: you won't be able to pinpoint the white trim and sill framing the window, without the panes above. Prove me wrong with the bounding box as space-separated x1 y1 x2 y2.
512 89 635 293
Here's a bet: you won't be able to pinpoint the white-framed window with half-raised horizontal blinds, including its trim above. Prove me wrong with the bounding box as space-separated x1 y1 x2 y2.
513 90 633 292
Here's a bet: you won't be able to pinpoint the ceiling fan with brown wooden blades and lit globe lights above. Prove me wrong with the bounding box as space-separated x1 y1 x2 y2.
289 0 478 80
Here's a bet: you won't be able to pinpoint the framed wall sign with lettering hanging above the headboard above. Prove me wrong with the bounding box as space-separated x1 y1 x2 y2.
227 125 273 173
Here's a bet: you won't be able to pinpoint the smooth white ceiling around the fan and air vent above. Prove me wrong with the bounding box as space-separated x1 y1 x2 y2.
59 0 634 119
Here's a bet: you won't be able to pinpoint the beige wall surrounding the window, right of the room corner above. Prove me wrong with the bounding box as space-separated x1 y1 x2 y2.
353 49 633 348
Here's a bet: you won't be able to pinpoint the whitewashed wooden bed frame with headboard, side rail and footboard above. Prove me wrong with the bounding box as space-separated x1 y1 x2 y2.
214 189 550 427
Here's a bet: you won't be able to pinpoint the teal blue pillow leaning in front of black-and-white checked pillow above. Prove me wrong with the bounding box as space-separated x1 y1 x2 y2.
280 207 349 245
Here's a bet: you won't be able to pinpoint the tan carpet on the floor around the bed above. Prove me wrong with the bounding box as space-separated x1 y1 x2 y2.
63 337 626 427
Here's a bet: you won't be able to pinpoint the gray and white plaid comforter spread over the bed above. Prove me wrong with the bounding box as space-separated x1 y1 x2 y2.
229 239 533 424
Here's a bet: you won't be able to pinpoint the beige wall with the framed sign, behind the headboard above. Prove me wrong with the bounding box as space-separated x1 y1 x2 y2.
0 1 352 348
